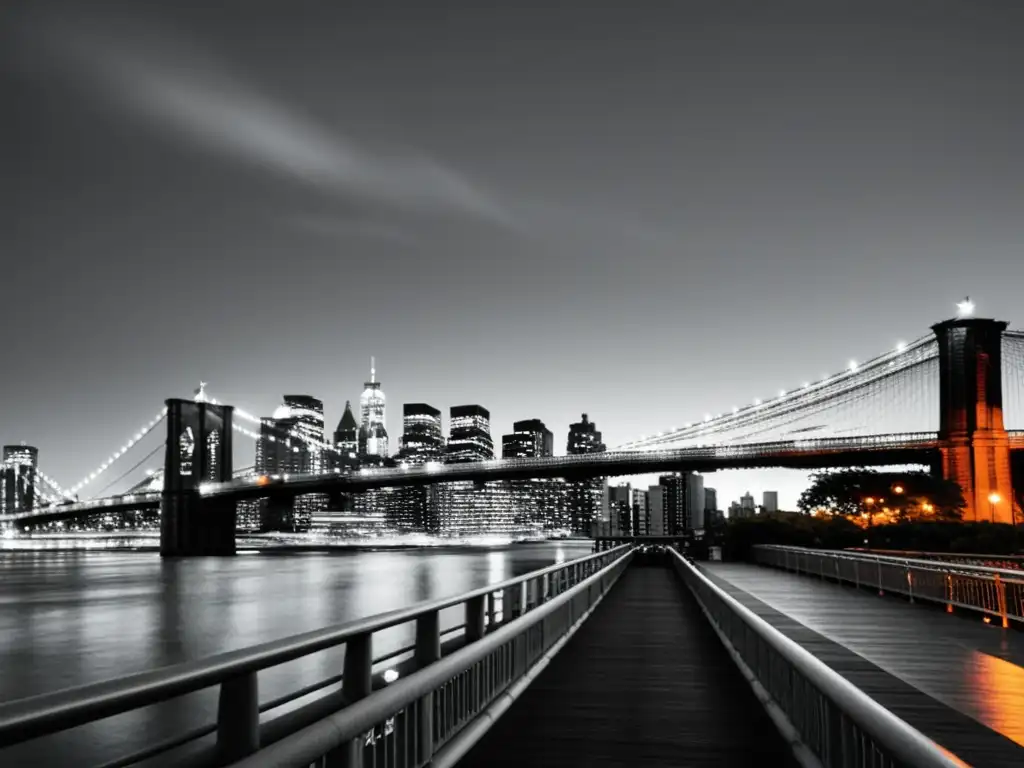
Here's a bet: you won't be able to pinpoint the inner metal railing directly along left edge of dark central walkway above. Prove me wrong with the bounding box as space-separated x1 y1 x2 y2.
223 547 632 768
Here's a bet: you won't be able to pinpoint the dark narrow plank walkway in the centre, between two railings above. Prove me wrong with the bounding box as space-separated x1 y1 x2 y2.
459 564 793 768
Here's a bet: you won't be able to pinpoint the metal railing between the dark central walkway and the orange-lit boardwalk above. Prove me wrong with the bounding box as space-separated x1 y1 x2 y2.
669 550 967 768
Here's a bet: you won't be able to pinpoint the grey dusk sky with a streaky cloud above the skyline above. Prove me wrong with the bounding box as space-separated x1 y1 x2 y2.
0 0 1024 507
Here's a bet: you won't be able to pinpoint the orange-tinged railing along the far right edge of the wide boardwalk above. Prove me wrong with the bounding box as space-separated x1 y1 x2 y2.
754 545 1024 627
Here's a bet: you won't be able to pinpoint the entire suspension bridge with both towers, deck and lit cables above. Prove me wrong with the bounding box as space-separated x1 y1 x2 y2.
0 313 1024 554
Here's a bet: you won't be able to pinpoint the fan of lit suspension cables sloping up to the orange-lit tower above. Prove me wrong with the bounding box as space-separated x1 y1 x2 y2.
627 337 938 450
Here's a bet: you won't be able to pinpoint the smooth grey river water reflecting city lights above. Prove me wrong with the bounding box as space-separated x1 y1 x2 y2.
0 542 591 768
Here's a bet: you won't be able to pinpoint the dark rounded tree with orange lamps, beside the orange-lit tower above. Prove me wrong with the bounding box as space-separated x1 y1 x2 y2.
799 469 966 524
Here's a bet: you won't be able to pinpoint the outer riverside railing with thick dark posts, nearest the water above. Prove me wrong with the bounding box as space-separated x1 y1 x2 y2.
0 546 631 766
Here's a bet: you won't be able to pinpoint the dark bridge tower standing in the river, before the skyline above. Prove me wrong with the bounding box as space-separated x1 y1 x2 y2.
160 398 236 557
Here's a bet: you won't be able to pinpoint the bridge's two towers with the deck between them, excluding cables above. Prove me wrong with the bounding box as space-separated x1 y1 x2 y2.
146 317 1024 556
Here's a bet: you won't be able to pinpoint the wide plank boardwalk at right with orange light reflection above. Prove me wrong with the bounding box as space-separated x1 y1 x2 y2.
705 563 1024 766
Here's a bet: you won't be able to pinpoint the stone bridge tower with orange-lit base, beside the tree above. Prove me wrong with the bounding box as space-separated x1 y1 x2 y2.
932 317 1015 523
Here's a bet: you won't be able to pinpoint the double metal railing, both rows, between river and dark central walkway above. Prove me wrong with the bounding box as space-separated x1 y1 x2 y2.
0 546 632 768
